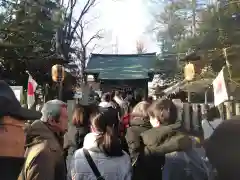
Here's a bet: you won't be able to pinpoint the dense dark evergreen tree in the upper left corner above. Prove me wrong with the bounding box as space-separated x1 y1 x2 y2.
0 0 63 85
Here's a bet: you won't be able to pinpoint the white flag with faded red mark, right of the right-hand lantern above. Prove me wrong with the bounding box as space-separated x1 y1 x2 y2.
213 70 228 106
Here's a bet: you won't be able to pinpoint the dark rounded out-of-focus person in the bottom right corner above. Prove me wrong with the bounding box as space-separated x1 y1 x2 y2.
205 118 240 180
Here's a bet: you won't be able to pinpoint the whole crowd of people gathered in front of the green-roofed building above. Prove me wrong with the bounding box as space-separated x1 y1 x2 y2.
0 81 240 180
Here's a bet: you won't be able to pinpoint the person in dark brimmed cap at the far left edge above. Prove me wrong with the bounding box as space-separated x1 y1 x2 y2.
0 80 42 180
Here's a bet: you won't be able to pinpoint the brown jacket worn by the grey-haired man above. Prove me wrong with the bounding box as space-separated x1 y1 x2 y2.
18 121 67 180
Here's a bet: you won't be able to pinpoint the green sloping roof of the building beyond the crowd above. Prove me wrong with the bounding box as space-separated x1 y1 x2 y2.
85 53 156 79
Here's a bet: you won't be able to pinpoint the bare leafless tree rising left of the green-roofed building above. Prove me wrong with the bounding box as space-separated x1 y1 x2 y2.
56 0 102 86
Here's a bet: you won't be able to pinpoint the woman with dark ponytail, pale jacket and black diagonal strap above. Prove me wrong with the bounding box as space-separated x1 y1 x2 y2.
71 111 131 180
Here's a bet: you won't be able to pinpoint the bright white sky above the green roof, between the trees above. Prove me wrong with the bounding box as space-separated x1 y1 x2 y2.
76 0 159 53
